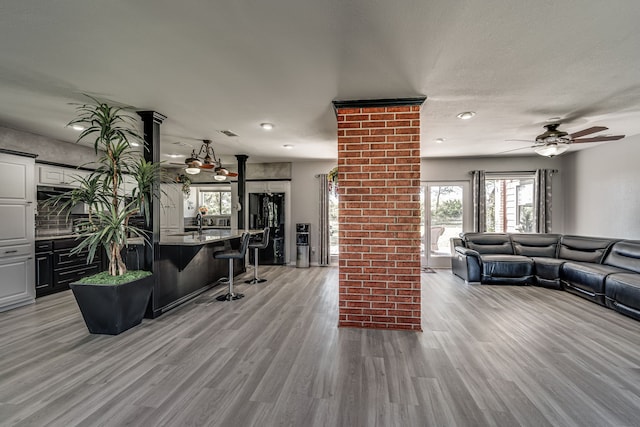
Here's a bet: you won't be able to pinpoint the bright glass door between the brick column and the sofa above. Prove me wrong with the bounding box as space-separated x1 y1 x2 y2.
421 181 470 268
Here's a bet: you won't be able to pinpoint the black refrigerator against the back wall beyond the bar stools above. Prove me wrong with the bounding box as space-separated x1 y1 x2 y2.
249 193 285 264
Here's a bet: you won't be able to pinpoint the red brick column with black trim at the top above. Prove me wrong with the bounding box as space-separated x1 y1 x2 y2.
334 97 425 331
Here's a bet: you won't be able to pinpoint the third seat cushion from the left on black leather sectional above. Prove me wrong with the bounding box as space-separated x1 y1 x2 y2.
560 261 626 305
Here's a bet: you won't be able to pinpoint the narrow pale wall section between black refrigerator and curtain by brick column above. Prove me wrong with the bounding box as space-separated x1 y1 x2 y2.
287 160 336 264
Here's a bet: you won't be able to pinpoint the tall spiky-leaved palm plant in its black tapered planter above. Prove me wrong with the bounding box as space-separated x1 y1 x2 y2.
50 98 160 335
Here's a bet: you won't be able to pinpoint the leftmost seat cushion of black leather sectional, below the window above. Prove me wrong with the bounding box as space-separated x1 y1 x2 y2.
480 255 533 284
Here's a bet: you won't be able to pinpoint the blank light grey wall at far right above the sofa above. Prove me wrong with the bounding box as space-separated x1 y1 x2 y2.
563 135 640 239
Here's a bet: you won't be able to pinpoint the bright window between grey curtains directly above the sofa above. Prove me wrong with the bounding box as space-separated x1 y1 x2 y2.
485 173 536 233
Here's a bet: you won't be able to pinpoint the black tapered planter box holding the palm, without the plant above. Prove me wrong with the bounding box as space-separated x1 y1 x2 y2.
70 276 154 335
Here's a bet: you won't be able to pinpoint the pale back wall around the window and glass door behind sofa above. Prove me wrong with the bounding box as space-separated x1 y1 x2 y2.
420 155 565 233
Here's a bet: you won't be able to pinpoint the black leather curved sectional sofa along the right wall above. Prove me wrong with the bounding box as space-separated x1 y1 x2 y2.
451 233 640 320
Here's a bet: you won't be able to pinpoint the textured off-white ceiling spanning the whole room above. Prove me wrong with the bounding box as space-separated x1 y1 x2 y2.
0 0 640 163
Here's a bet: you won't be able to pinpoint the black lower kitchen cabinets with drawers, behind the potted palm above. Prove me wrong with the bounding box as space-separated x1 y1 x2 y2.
36 239 104 297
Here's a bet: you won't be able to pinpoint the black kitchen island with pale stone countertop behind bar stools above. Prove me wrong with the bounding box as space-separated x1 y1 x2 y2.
146 229 262 318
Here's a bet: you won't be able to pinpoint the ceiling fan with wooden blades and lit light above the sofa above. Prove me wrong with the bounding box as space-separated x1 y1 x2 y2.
510 123 625 157
